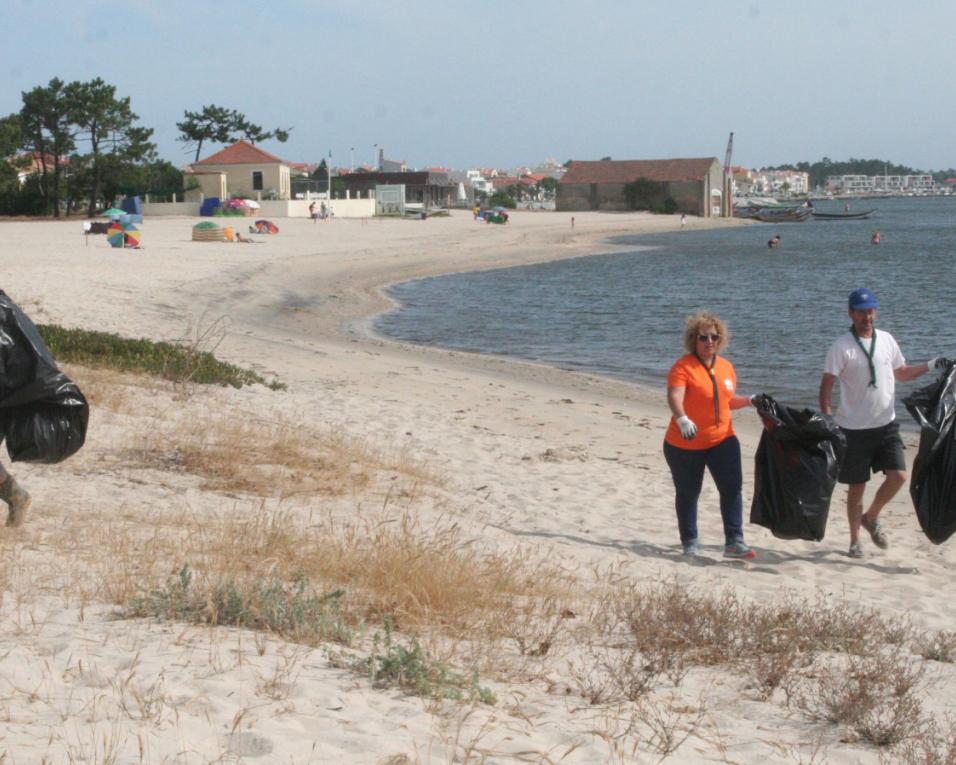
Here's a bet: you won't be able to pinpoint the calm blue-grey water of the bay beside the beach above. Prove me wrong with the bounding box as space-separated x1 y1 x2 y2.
376 198 956 419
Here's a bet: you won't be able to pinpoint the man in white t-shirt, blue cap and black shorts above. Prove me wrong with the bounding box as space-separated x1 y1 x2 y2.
820 288 948 558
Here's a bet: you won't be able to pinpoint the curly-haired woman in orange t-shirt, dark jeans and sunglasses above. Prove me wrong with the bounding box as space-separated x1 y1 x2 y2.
664 312 757 559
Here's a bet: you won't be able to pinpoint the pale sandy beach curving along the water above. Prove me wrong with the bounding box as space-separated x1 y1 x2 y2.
0 212 956 765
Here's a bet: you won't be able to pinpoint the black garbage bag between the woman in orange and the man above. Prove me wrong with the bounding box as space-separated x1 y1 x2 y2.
750 395 846 542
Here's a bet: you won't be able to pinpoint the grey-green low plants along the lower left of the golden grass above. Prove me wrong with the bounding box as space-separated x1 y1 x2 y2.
123 564 354 645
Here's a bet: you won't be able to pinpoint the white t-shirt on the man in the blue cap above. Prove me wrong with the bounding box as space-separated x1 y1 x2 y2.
823 329 906 430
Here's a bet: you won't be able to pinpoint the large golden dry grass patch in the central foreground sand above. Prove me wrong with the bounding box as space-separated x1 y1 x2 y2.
109 508 570 639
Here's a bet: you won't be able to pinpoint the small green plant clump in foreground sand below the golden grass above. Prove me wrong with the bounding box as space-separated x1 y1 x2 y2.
352 616 497 704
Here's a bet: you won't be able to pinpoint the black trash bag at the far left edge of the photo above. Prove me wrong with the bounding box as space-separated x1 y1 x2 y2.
0 290 90 464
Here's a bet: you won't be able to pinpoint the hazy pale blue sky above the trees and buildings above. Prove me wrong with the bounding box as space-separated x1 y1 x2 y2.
7 0 956 169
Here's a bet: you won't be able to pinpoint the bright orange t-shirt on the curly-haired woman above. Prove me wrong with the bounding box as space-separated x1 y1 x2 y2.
664 353 737 449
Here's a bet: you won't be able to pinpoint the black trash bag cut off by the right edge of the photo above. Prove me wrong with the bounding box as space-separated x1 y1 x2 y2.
903 361 956 544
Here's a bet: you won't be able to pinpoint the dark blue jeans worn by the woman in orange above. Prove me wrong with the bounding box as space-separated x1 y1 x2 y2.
664 436 744 544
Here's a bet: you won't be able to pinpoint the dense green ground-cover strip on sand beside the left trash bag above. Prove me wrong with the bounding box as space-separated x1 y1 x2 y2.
37 324 286 390
